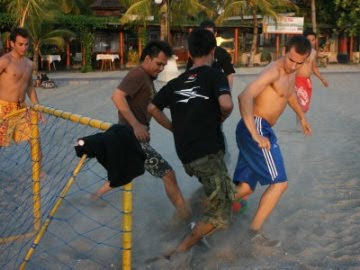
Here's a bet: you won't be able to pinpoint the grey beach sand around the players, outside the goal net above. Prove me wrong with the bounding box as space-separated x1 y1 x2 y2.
1 66 360 270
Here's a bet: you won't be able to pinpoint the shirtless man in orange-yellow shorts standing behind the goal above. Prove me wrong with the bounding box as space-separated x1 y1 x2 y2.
0 28 44 147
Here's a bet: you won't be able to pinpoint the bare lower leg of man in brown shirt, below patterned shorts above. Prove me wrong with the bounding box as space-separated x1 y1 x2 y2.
162 171 190 218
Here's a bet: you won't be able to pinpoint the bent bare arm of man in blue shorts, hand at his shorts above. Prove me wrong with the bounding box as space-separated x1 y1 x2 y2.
238 63 280 150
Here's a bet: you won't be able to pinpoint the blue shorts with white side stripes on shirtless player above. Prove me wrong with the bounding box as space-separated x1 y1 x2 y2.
233 117 287 190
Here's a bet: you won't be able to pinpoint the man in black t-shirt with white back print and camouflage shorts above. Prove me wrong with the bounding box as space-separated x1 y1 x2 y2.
148 29 234 255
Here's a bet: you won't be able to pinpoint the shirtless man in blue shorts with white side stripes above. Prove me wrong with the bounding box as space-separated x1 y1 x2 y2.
234 36 311 245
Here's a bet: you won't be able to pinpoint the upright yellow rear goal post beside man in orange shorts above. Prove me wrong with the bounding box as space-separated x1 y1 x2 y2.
29 110 41 231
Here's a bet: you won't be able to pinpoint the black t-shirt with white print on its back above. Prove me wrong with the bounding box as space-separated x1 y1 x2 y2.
152 66 231 164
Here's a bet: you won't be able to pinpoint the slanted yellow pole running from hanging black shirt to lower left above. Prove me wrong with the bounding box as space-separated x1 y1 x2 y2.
19 155 87 270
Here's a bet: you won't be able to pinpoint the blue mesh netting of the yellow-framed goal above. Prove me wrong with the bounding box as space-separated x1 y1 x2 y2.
0 107 128 269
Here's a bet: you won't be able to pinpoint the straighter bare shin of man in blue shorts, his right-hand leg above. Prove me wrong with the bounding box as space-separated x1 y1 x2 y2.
250 182 288 231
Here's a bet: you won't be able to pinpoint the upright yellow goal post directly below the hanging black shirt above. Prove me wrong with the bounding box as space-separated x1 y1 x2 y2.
122 183 132 270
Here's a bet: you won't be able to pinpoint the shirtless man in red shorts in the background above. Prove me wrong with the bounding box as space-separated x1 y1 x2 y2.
295 32 329 117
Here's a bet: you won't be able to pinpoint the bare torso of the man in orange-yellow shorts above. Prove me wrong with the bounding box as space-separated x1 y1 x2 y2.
0 53 32 102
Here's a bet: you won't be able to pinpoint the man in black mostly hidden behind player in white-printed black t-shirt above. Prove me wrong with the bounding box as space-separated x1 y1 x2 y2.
186 20 235 89
